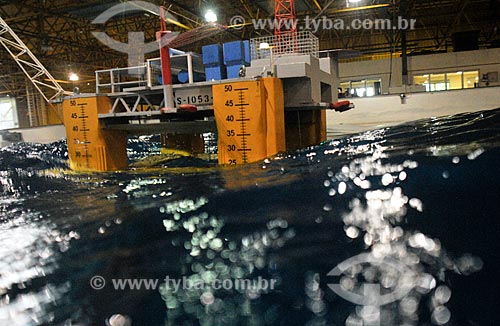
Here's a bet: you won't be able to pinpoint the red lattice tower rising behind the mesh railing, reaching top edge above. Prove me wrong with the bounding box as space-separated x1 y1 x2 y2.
274 0 297 54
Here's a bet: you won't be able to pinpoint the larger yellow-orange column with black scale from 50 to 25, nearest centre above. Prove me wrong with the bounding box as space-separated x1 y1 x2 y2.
213 78 285 165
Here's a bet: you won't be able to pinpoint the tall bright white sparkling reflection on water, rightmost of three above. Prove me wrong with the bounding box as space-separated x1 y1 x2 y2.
331 148 482 325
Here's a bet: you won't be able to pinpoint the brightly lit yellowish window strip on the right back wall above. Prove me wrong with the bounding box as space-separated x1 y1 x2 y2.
413 70 479 92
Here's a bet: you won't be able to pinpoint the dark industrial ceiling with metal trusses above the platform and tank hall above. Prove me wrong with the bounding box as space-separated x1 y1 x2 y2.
0 0 500 97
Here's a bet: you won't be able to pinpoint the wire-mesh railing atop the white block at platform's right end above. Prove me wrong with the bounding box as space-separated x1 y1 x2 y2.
250 31 319 60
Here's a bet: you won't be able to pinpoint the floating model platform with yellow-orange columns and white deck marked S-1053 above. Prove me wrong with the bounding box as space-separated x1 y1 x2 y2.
63 32 346 171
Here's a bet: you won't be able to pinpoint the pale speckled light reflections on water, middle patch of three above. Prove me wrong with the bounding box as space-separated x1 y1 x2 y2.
160 198 294 325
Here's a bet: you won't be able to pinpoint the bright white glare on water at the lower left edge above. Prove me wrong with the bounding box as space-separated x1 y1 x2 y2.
0 219 73 325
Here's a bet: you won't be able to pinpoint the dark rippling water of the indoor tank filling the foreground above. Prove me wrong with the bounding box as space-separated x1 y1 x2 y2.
0 110 500 325
